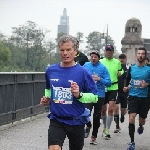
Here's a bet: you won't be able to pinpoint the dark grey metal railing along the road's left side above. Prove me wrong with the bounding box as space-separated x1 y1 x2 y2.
0 72 45 125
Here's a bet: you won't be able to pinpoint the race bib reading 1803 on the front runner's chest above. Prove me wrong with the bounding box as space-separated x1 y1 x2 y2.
53 87 73 104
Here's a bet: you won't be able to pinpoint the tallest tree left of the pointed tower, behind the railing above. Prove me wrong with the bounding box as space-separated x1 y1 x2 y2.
11 21 49 71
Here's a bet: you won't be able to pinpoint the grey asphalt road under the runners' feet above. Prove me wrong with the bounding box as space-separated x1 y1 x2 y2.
0 113 150 150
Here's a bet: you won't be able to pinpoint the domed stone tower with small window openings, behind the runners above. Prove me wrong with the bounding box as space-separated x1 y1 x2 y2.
121 18 144 64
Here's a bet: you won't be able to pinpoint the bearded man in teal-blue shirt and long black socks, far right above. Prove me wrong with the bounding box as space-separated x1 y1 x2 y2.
123 47 150 150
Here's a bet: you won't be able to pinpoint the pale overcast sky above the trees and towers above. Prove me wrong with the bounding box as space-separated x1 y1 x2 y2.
0 0 150 51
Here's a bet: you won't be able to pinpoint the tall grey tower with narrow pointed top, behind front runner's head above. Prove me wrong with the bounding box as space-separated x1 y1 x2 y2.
58 8 69 35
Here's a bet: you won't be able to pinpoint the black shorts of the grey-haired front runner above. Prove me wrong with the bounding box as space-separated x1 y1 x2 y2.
48 120 84 150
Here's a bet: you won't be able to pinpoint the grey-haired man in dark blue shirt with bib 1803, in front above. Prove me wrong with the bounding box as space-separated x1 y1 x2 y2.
40 35 98 150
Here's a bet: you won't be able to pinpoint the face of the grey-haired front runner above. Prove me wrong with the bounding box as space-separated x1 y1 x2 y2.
59 41 76 63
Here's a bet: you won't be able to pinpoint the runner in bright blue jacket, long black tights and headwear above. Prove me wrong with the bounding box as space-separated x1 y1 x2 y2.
84 50 111 145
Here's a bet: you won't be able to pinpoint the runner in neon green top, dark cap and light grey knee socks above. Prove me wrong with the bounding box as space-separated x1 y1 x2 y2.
100 44 123 139
